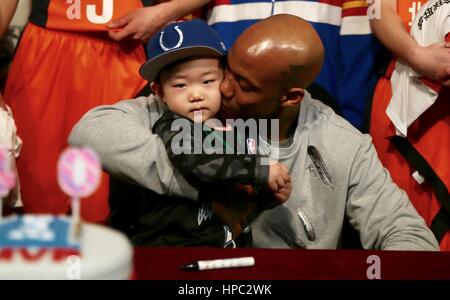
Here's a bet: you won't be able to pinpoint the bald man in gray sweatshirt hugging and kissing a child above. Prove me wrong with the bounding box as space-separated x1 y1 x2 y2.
70 15 438 250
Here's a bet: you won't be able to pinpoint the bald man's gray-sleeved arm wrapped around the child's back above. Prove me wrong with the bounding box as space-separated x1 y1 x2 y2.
69 97 198 200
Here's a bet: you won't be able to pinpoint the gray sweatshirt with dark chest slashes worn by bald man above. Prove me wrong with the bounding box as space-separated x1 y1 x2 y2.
69 93 439 250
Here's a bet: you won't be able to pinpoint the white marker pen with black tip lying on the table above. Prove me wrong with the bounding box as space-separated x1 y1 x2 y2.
181 256 255 271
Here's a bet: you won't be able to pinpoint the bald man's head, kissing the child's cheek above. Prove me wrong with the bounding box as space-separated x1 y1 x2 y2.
221 15 324 118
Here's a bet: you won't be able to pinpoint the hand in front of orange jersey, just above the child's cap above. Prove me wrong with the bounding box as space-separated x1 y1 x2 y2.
107 5 170 43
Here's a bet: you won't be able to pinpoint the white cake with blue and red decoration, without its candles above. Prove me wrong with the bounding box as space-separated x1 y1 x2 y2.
0 215 133 279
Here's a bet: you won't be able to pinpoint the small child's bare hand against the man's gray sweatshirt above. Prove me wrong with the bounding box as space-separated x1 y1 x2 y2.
268 162 292 204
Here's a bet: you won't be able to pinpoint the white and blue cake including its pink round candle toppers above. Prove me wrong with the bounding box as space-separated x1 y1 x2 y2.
0 148 133 279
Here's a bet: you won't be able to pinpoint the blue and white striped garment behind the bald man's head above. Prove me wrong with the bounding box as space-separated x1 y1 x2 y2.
207 0 382 129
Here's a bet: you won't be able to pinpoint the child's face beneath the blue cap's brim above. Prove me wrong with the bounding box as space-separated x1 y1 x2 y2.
160 58 223 122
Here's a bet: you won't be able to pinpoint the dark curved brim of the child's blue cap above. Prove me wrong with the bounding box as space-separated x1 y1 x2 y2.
139 46 224 82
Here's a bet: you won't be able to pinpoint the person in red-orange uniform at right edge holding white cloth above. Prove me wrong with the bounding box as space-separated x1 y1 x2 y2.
370 0 450 251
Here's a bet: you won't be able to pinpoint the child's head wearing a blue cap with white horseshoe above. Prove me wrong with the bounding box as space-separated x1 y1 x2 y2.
140 20 226 121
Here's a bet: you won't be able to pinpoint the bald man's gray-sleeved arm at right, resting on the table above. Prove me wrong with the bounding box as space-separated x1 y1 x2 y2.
346 136 439 251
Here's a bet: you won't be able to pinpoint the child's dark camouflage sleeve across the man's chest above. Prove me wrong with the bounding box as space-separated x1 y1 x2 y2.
152 111 269 187
